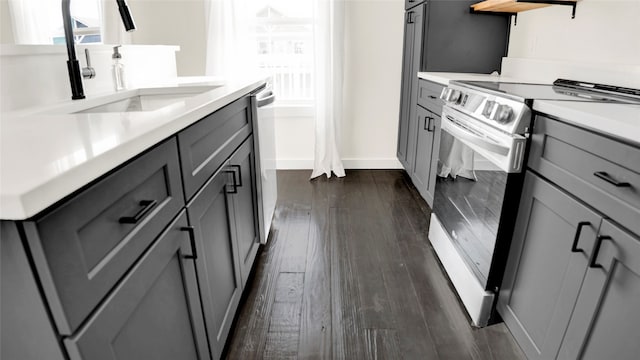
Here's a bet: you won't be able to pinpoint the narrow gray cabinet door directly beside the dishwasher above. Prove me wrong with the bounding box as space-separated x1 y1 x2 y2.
229 137 260 288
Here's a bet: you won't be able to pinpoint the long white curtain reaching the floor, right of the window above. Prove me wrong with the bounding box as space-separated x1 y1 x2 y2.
311 0 345 179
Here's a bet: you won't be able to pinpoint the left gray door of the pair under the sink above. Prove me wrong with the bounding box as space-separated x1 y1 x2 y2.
187 167 242 359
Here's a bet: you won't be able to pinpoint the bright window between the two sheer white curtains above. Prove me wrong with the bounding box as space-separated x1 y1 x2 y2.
253 0 314 106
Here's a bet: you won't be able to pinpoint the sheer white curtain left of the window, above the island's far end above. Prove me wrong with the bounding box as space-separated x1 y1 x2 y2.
206 0 256 78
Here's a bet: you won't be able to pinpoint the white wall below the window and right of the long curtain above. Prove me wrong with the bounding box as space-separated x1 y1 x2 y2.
276 0 404 169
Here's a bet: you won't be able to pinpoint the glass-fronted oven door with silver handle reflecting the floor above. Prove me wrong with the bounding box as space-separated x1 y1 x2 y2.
433 106 526 287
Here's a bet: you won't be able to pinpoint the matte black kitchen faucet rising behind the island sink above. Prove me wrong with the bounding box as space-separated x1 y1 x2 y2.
62 0 136 100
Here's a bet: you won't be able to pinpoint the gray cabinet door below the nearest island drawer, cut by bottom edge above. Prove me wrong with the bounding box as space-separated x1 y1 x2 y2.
64 213 210 360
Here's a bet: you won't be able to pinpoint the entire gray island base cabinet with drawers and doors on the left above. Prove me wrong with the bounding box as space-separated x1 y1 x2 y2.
0 90 262 360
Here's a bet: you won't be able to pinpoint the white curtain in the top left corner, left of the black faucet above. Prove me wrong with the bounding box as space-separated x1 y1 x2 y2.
9 0 57 44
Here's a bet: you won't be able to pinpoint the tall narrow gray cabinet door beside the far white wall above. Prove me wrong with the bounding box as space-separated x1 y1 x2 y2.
407 5 424 174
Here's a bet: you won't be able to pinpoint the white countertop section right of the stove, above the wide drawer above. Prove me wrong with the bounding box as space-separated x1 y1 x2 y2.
533 100 640 146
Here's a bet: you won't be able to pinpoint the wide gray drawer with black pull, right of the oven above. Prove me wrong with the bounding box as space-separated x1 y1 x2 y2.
528 115 640 233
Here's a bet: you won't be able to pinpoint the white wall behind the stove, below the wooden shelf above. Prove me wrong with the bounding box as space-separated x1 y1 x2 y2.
503 0 640 87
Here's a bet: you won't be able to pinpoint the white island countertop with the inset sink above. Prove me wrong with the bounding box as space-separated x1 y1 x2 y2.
0 77 265 220
